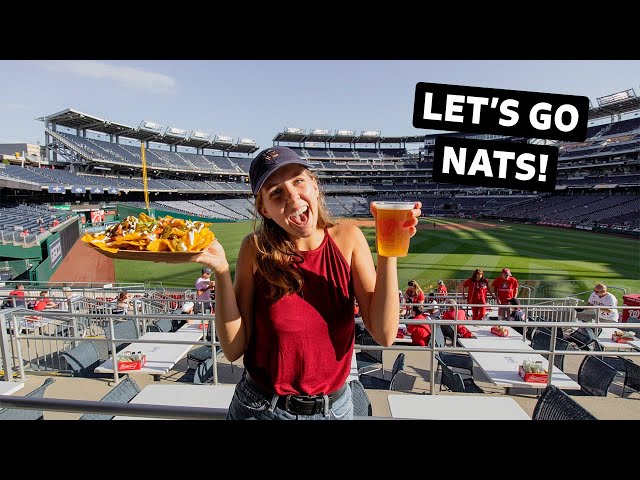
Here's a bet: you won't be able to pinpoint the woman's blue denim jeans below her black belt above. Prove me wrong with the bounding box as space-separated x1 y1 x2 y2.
227 374 353 420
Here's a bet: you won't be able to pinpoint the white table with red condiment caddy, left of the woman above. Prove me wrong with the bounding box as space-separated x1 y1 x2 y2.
94 330 202 381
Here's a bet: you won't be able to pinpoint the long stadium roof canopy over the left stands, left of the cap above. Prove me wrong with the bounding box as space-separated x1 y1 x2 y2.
36 108 259 153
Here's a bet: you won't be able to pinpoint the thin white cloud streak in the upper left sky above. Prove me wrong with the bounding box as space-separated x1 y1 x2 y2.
36 60 176 93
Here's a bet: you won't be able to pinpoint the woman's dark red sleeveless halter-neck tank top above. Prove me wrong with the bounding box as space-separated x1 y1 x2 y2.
244 230 355 395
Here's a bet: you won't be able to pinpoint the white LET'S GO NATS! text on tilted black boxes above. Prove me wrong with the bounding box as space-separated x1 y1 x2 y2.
413 82 589 192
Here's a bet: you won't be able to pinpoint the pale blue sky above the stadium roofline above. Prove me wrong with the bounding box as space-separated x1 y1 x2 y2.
0 60 640 147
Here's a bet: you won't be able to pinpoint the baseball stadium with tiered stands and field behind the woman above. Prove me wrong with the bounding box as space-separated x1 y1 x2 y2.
0 89 640 420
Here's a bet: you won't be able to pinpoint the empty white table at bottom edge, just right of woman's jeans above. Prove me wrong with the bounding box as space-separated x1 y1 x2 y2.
387 395 531 420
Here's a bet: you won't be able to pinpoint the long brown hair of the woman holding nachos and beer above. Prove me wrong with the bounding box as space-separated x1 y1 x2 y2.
253 170 334 302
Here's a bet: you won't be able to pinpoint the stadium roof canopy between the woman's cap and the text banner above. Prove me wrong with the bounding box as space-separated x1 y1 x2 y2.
273 128 424 143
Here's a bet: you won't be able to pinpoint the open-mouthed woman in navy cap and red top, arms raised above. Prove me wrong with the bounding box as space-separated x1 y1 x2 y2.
192 146 421 420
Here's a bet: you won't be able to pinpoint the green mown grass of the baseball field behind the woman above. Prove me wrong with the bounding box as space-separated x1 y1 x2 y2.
116 218 640 303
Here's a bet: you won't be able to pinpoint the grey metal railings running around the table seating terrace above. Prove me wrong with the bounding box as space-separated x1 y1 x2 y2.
0 299 640 419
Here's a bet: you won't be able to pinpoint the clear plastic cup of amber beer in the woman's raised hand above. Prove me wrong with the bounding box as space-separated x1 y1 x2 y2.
373 202 415 257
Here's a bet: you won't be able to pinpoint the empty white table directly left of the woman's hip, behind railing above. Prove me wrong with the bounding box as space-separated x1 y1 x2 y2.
113 384 236 420
